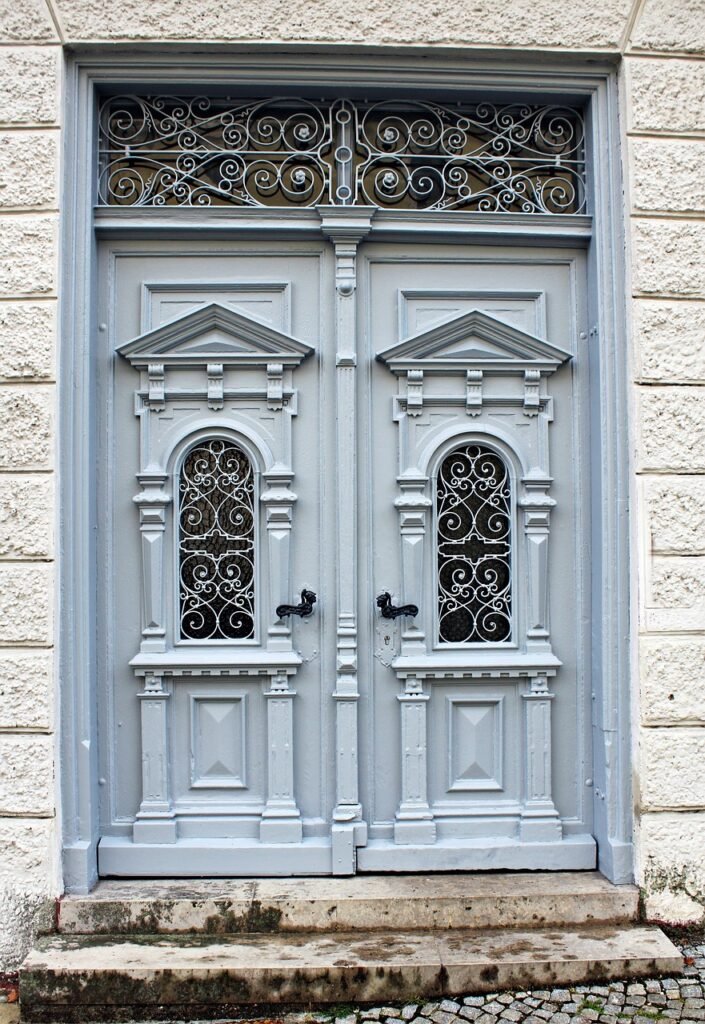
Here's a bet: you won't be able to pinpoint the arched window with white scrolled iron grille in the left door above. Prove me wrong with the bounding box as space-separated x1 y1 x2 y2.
178 439 255 640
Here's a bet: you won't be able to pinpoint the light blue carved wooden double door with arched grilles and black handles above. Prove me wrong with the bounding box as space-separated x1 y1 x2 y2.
96 240 595 877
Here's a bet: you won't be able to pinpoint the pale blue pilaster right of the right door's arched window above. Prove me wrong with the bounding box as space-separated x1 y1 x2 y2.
520 475 555 651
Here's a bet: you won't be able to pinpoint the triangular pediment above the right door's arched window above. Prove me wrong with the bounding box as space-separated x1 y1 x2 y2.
377 309 571 373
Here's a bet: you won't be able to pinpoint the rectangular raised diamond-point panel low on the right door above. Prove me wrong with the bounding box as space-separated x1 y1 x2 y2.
448 697 503 792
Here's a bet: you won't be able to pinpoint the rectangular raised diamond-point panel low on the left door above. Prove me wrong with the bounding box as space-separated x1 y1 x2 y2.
191 693 247 790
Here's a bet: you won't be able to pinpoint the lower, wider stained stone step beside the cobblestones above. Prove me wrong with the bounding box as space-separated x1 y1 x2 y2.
19 926 682 1022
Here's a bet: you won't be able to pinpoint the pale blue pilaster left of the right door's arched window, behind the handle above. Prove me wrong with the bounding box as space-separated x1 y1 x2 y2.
395 476 432 654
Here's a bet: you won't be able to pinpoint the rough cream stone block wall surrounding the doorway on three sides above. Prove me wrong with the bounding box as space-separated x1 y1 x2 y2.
0 0 705 970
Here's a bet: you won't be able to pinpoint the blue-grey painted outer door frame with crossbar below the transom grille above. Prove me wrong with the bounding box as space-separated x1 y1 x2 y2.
61 45 633 892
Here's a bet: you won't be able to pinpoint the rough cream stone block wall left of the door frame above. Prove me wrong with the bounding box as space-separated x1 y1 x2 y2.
0 0 63 971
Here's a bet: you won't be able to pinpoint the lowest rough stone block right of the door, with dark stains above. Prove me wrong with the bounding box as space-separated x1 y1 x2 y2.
637 811 705 923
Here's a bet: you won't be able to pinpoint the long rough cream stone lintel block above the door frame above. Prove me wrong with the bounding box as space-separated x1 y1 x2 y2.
53 0 630 49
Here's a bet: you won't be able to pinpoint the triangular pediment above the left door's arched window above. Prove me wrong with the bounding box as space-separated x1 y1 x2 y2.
118 302 314 368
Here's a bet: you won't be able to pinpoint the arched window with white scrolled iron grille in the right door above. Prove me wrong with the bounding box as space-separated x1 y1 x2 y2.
436 444 511 643
